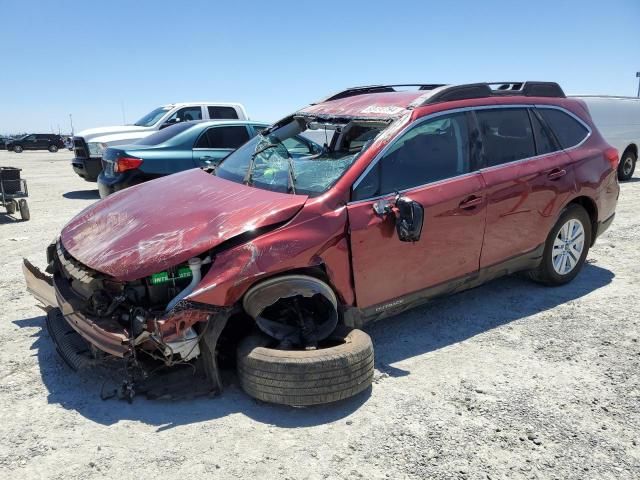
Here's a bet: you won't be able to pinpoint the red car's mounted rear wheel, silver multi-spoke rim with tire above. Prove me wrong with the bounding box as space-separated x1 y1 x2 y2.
528 204 591 286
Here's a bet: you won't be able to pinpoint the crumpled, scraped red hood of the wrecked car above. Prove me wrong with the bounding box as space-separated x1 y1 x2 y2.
61 169 307 280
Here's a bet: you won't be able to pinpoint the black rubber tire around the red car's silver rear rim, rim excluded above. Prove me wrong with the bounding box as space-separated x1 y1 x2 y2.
527 203 592 286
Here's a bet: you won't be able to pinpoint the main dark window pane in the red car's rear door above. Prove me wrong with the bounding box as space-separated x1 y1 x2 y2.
476 108 536 167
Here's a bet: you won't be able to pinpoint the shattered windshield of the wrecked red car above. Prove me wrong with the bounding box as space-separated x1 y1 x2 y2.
215 117 388 196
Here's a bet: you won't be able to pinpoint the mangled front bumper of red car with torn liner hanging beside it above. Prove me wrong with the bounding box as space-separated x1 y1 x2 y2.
22 259 232 393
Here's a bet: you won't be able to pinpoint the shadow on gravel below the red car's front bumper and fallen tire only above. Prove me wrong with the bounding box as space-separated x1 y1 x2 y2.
13 316 371 431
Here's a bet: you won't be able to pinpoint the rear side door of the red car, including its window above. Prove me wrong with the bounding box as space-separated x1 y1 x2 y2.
475 107 574 268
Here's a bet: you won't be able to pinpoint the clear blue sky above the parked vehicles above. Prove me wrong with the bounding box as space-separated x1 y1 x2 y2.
0 0 640 133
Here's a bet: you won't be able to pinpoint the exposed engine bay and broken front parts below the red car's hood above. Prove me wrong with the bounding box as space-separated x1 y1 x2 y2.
47 241 218 364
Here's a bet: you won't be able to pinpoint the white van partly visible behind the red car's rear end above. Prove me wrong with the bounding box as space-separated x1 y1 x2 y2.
573 95 640 180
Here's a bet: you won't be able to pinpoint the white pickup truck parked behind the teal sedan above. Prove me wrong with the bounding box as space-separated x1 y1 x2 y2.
71 102 249 182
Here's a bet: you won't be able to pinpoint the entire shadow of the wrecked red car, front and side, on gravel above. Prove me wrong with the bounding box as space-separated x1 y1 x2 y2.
13 264 614 431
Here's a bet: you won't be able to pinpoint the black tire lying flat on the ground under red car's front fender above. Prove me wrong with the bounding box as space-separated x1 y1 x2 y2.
238 326 373 406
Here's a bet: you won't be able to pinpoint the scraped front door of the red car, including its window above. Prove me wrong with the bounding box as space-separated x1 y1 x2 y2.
347 113 486 311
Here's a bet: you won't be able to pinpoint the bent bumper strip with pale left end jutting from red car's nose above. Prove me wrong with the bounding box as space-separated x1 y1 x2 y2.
22 259 131 357
